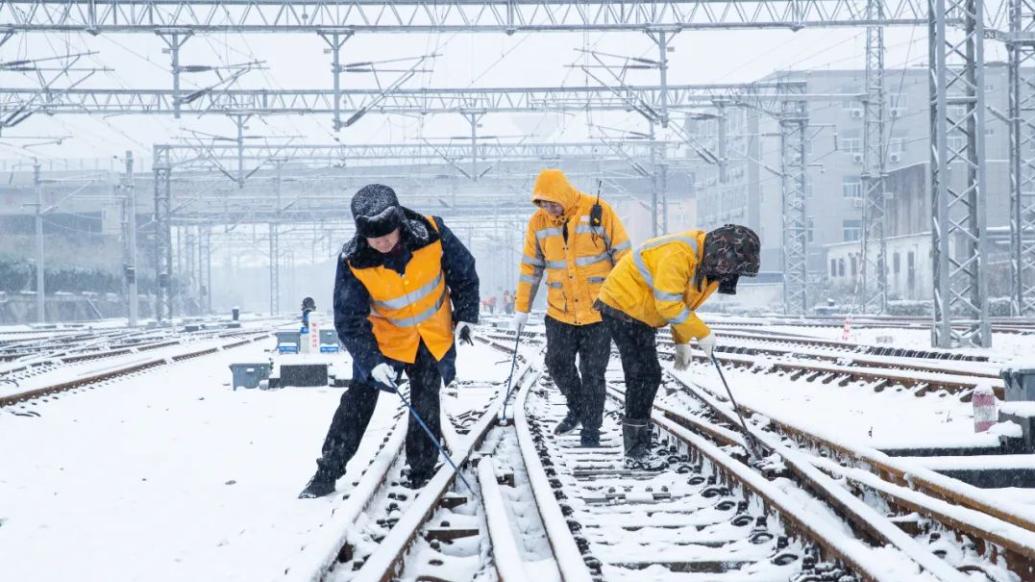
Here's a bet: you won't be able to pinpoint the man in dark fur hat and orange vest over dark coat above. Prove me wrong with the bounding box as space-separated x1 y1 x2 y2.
299 184 478 498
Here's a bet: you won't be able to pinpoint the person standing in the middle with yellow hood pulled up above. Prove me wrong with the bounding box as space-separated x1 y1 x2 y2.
514 169 630 446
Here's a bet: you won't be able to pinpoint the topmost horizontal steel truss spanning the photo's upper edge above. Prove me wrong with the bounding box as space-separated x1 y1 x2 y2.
0 0 943 34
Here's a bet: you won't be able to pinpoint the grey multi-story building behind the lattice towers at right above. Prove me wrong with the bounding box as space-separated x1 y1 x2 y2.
687 63 1009 304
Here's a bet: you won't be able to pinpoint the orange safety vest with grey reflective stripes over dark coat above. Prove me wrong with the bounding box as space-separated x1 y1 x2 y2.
349 216 453 363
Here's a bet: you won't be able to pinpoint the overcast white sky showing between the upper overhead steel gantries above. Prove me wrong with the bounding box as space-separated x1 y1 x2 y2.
0 27 1004 163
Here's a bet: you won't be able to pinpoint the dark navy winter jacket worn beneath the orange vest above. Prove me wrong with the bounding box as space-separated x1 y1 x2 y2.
334 208 479 384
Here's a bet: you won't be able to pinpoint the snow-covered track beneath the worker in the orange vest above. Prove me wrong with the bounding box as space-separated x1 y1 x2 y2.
284 338 515 581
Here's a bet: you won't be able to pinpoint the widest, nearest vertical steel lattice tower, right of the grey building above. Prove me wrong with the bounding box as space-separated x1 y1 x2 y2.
928 0 992 348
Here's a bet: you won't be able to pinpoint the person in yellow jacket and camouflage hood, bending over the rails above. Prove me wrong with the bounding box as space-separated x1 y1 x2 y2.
596 225 760 469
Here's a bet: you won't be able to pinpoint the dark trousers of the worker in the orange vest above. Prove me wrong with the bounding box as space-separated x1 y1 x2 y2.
317 342 442 479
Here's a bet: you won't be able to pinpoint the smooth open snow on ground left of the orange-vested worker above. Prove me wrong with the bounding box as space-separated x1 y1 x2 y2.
0 343 396 580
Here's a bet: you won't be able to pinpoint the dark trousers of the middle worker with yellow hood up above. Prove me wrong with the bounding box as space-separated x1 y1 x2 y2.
546 316 611 431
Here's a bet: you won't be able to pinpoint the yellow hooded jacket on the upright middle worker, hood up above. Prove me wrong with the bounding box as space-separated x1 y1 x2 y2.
514 170 630 325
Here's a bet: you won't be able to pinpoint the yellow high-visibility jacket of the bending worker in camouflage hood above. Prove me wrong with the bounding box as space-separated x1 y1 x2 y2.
599 230 718 344
